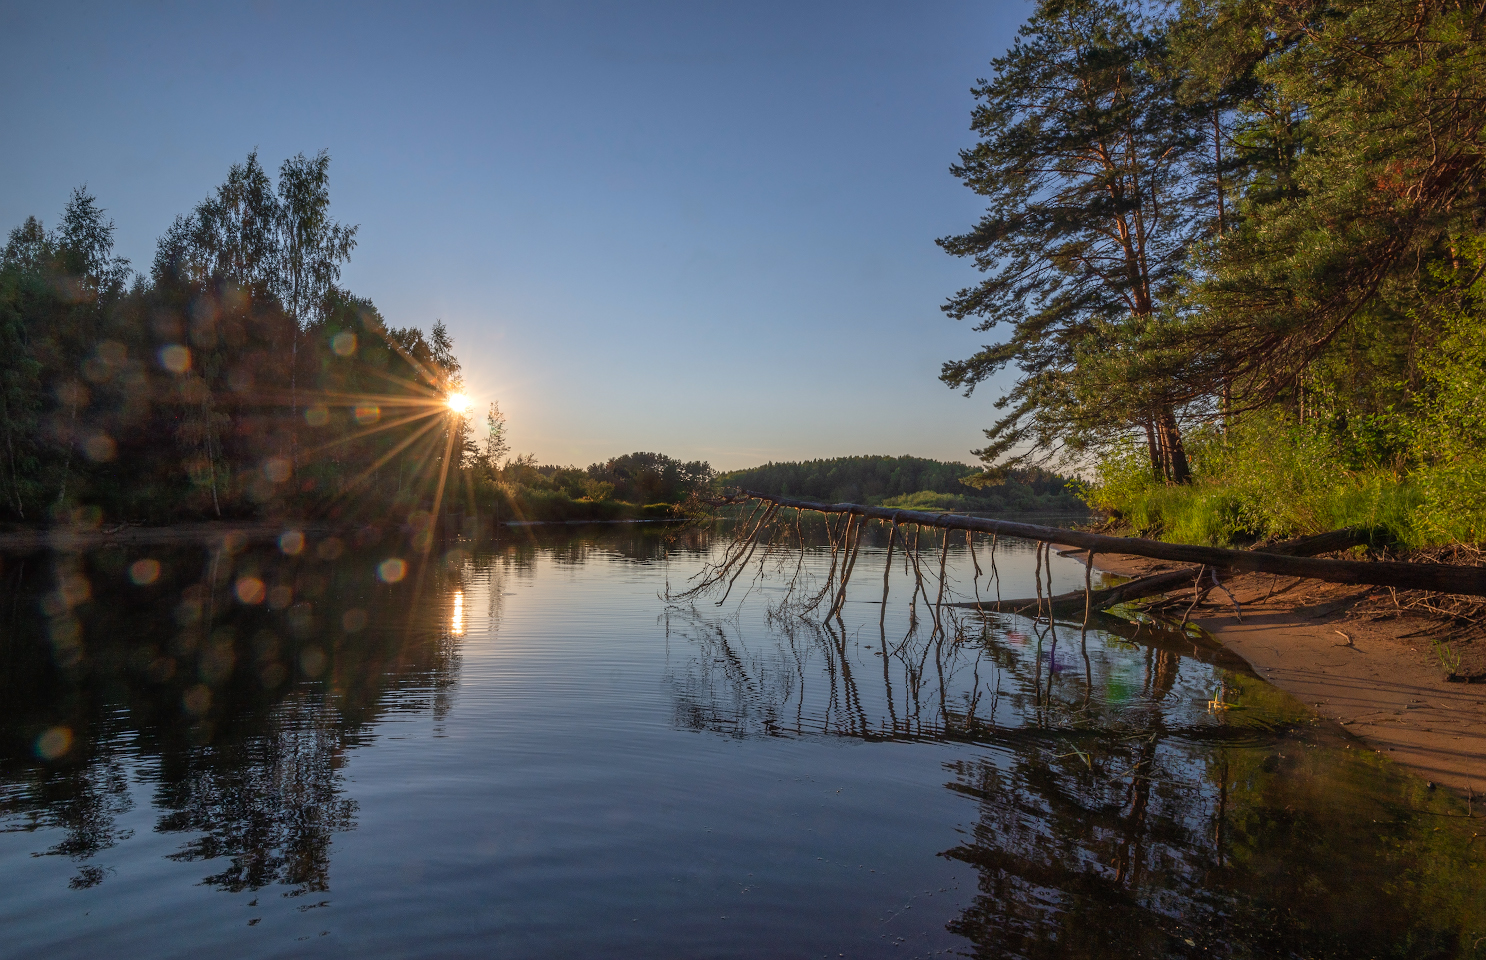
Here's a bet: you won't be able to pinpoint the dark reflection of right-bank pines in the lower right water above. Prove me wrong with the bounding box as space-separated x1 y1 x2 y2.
944 707 1483 957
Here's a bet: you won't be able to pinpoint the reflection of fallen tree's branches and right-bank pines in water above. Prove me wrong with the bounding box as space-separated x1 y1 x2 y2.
667 537 1486 959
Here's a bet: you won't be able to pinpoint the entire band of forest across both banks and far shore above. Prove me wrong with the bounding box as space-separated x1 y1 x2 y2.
0 0 1486 548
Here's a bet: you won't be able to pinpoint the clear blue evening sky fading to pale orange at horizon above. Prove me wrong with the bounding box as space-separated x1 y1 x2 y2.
0 0 1030 470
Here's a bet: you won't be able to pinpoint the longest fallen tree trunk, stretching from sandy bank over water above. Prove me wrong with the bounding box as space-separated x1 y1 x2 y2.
734 490 1486 596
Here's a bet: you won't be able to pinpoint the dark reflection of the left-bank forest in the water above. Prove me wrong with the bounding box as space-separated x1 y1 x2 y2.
0 532 465 896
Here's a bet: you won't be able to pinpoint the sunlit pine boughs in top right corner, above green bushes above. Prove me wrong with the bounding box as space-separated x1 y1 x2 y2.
1172 0 1486 410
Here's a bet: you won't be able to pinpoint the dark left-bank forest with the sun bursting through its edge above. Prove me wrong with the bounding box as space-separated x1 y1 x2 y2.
0 153 712 533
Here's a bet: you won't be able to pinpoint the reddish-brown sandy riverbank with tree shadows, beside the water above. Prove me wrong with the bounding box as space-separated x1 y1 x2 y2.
1067 551 1486 798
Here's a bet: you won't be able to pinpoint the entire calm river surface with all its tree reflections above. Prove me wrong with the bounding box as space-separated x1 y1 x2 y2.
0 528 1486 957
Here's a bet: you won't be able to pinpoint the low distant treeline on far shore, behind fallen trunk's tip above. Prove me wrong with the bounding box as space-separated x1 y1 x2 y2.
718 456 1085 511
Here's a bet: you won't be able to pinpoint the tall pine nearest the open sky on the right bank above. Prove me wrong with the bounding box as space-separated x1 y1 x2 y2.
939 0 1207 481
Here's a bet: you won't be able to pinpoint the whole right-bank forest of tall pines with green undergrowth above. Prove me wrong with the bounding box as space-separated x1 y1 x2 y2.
939 0 1486 548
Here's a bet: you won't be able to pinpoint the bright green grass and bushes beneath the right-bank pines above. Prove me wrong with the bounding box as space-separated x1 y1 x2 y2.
1082 291 1486 550
